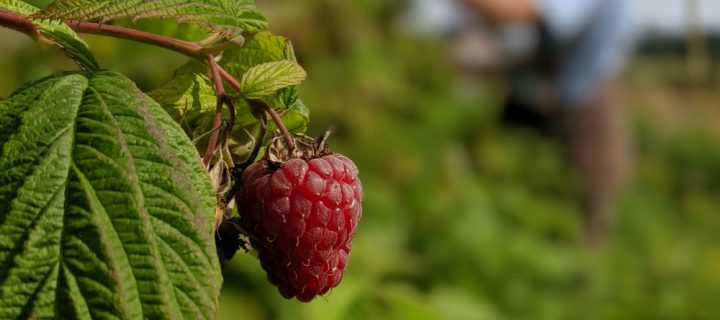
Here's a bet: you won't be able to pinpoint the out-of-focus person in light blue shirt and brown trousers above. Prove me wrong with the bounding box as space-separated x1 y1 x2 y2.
410 0 632 244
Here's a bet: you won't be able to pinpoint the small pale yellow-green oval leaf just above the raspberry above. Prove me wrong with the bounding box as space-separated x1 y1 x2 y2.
241 60 307 99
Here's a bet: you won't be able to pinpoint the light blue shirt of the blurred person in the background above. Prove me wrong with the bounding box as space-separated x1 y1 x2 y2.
535 0 633 106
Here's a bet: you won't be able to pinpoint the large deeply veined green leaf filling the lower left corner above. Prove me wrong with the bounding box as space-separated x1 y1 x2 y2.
0 72 221 319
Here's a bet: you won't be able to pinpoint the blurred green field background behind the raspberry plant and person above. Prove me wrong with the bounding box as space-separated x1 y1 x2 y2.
0 0 720 319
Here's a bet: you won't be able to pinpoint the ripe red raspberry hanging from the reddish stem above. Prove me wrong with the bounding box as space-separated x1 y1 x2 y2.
237 154 362 302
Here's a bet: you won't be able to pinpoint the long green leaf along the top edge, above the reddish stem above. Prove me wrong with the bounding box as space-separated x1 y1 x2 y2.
38 0 267 39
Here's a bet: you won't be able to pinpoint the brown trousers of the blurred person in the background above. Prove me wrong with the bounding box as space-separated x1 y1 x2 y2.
561 82 633 245
